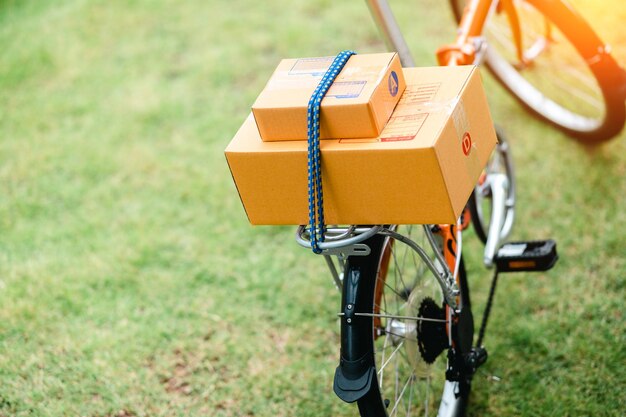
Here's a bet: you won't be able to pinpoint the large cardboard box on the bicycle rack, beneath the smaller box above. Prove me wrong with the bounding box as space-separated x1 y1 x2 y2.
226 66 496 225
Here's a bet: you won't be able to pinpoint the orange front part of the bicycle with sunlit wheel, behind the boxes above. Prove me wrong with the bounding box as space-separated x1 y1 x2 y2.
368 0 626 144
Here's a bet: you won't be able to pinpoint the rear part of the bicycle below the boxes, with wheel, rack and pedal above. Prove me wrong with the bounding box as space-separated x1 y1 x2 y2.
296 0 568 417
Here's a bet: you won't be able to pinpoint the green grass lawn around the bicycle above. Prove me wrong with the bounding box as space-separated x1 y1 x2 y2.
0 0 626 417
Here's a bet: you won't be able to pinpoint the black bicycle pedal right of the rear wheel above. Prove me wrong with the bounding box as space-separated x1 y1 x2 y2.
494 239 559 272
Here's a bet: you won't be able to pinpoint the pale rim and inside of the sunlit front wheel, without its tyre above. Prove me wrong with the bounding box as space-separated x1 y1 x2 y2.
484 0 606 132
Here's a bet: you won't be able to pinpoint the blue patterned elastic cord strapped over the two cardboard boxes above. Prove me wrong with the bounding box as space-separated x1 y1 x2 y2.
307 51 356 254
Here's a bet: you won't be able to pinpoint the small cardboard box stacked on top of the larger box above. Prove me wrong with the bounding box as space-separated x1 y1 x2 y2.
252 53 405 141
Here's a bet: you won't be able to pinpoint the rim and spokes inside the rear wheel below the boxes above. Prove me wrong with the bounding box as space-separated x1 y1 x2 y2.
373 226 456 416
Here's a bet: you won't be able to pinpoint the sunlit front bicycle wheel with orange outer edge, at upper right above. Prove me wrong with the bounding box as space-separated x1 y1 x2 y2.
450 0 626 143
